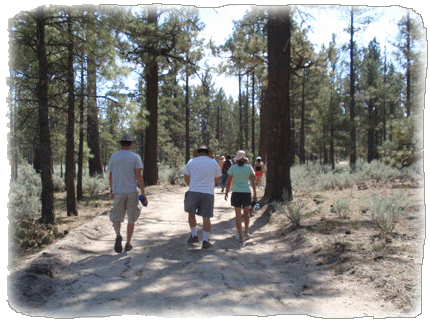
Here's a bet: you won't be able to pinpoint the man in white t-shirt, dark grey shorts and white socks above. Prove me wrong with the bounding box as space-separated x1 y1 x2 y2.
183 145 222 248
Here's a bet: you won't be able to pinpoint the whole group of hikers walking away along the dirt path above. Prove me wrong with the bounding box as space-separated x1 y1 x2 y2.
108 134 264 253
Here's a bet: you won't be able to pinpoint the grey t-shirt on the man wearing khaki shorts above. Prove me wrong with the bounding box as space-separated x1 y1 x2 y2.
108 150 143 194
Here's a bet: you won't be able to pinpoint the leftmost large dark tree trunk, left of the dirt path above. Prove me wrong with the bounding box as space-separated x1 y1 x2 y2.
34 6 55 223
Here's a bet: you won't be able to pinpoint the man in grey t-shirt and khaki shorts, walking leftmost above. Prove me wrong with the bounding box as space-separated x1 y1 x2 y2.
108 134 147 253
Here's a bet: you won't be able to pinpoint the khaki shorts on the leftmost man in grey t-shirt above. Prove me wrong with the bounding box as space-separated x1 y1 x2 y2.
109 192 142 224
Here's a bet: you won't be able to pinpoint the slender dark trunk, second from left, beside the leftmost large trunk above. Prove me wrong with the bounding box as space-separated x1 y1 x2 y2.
66 10 78 216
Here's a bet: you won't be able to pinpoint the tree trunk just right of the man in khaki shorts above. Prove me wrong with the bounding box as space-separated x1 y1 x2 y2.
143 6 158 185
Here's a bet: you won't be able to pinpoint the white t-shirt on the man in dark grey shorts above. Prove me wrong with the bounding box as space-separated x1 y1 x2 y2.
183 156 222 195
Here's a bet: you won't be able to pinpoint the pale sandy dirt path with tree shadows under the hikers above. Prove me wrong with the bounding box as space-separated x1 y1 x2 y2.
9 188 414 318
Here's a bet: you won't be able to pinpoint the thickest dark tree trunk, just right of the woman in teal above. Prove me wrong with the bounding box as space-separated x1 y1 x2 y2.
264 6 293 201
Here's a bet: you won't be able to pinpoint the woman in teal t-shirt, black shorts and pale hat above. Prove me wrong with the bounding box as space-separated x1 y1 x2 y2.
225 150 257 242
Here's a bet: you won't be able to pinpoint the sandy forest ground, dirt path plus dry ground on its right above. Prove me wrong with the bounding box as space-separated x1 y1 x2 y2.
8 178 425 318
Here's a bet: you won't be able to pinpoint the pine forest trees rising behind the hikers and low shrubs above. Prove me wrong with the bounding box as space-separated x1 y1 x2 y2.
7 5 427 222
